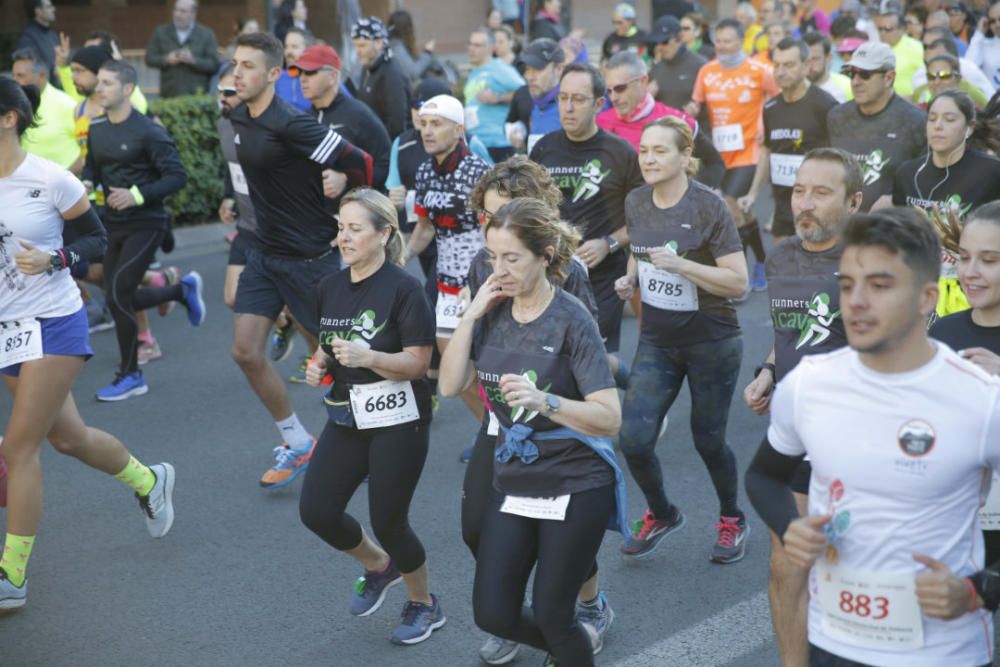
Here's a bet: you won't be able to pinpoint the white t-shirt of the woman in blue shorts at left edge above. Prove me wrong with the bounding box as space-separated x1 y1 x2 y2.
0 153 86 322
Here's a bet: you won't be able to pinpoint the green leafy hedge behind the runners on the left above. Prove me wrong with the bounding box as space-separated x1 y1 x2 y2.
150 95 225 224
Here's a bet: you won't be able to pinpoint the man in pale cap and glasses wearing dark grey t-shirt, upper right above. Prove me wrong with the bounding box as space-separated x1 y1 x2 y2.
826 42 927 211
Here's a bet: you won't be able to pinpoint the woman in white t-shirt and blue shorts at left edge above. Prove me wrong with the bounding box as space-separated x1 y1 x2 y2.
0 76 174 611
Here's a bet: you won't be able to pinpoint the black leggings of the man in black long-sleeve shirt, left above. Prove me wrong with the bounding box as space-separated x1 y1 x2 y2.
104 228 184 375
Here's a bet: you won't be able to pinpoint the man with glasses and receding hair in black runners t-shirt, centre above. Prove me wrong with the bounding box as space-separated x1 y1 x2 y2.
531 63 642 376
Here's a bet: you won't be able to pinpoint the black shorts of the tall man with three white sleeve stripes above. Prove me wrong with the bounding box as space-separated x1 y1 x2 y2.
233 247 340 336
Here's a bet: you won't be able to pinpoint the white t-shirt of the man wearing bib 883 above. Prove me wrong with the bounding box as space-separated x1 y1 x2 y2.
768 344 1000 667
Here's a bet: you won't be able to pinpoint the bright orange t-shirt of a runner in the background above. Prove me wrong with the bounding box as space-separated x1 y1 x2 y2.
691 58 780 169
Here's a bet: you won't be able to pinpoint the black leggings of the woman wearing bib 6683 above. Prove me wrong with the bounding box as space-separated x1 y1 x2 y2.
299 421 430 574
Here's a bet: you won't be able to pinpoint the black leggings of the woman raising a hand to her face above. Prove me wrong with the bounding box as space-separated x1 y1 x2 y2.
472 485 615 667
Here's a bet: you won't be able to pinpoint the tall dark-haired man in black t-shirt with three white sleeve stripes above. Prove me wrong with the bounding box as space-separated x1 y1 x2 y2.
229 33 372 489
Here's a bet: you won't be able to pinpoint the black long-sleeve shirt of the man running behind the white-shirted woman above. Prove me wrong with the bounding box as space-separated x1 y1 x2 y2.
83 109 187 229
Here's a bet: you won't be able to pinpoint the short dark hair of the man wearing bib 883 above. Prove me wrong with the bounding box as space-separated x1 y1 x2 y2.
843 206 941 282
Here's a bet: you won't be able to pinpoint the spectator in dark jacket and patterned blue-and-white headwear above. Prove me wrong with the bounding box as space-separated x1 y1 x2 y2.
351 16 410 139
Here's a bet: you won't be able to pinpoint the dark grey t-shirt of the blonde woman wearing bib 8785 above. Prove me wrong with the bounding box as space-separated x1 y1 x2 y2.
625 181 743 348
